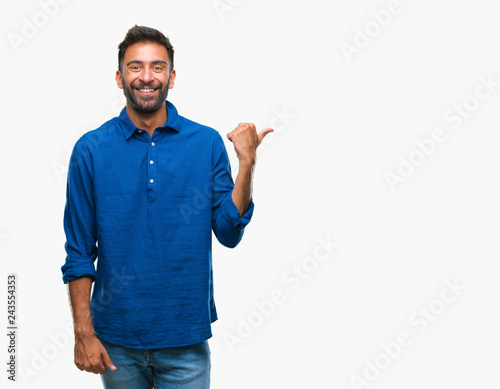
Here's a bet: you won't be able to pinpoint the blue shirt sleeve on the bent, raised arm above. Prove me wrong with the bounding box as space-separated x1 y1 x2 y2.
212 136 254 248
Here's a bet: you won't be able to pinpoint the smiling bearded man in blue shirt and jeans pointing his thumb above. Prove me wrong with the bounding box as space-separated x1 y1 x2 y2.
61 26 273 389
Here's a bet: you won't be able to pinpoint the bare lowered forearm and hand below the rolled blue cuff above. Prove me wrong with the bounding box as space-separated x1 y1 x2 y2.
68 277 116 374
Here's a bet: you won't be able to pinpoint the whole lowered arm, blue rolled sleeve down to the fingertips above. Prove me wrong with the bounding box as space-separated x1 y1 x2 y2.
61 137 116 374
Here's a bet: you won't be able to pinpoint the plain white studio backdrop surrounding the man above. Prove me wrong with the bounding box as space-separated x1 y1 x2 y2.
0 0 500 389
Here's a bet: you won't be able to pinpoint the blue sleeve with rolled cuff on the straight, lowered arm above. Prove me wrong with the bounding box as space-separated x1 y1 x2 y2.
61 137 97 283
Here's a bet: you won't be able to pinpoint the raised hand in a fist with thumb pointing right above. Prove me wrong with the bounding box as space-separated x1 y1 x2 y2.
227 123 274 165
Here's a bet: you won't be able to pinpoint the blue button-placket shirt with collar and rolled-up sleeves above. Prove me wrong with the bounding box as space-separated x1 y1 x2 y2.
61 101 254 349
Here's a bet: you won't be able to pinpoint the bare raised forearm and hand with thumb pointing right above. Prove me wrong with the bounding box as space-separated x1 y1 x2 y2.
227 123 274 217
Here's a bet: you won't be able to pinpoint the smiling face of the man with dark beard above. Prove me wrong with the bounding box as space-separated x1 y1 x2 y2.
116 43 175 114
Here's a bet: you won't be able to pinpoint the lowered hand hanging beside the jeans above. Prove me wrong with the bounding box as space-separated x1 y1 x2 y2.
75 335 116 374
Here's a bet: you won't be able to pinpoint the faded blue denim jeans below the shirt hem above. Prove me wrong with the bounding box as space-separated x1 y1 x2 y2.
99 338 210 389
